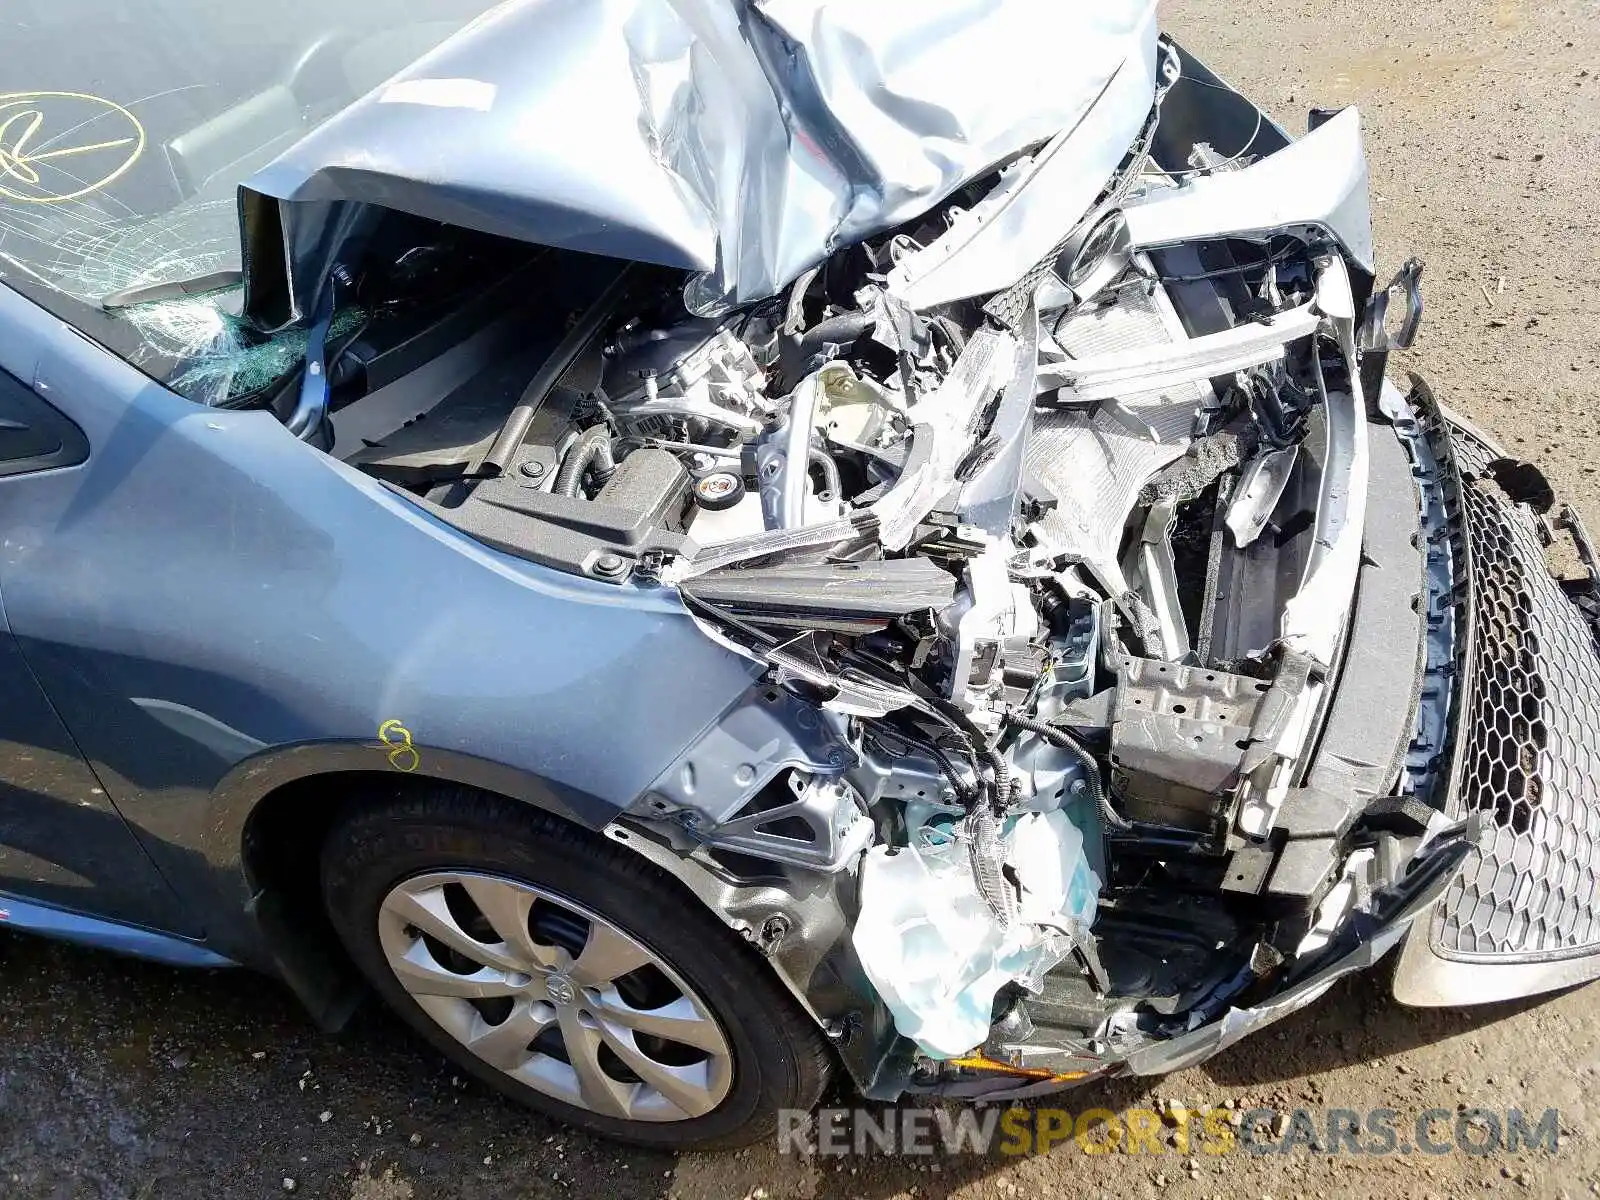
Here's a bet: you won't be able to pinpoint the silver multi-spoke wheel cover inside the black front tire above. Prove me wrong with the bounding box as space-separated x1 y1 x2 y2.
378 870 733 1122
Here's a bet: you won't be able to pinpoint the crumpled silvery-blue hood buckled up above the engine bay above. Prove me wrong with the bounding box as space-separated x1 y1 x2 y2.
240 0 1157 326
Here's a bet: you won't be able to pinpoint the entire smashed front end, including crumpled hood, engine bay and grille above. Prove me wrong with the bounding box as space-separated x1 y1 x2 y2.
50 0 1600 1098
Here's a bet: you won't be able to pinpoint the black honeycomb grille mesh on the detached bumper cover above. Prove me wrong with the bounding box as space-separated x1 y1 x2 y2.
1432 430 1600 962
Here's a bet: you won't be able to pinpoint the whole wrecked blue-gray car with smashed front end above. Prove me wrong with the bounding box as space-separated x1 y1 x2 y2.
0 0 1600 1149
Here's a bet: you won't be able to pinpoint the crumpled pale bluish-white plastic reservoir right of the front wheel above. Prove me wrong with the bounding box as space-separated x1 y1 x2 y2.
851 811 1099 1059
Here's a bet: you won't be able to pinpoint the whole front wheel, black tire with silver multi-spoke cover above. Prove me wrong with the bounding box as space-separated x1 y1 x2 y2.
322 787 832 1150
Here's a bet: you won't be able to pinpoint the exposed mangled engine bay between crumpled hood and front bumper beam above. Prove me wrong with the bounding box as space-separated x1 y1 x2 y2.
302 32 1472 1094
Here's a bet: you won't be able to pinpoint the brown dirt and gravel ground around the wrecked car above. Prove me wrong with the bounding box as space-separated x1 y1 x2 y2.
0 0 1600 1200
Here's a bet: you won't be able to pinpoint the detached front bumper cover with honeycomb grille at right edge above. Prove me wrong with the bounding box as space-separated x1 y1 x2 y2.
1395 398 1600 1005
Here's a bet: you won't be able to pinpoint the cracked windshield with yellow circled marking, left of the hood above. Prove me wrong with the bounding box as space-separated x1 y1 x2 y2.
0 0 493 302
